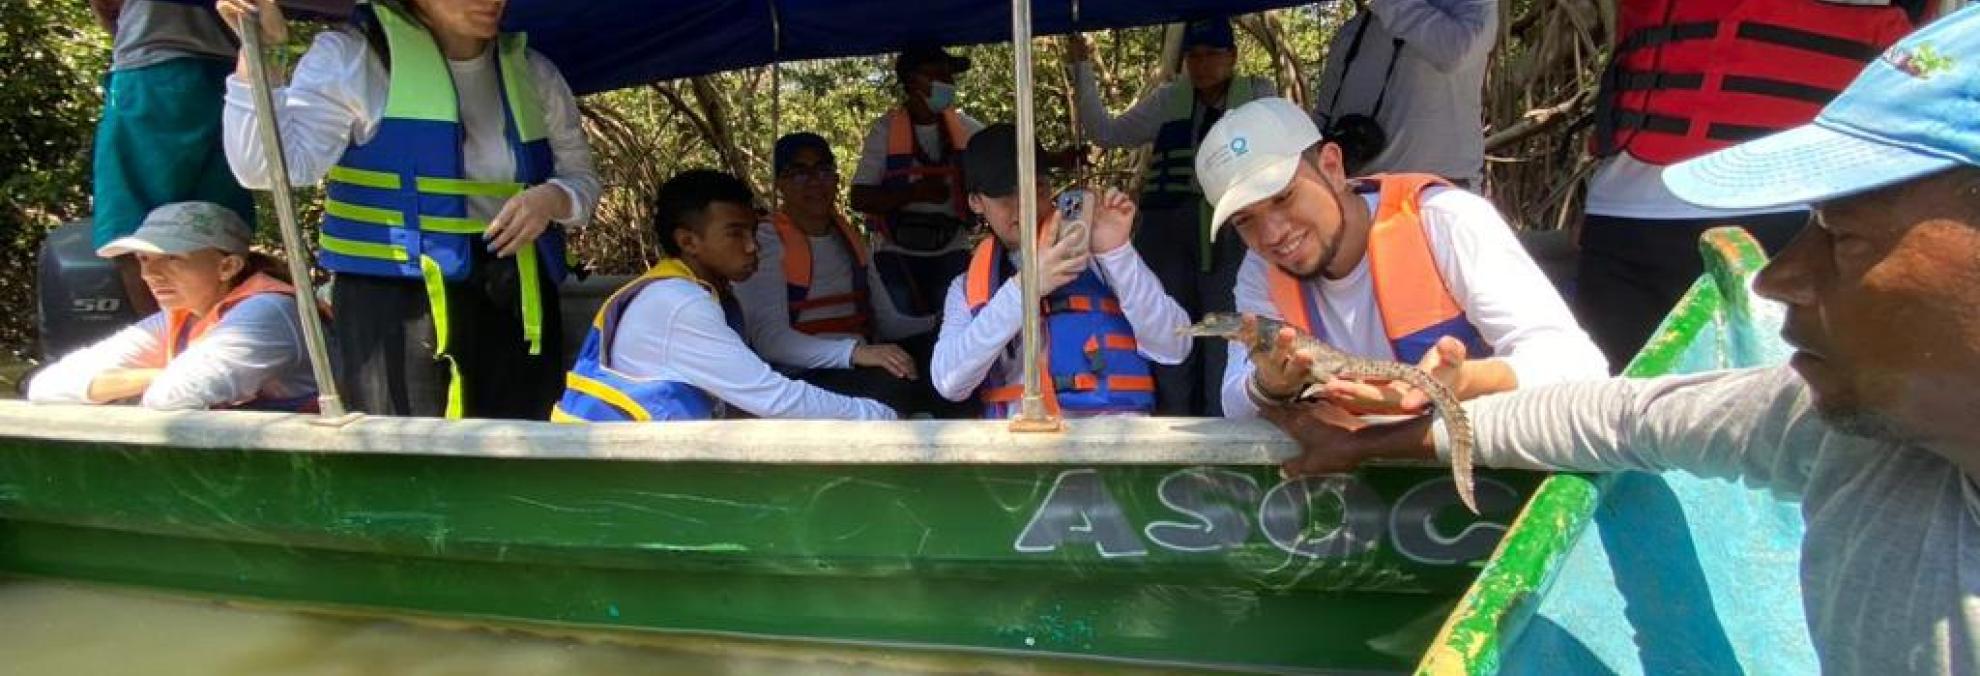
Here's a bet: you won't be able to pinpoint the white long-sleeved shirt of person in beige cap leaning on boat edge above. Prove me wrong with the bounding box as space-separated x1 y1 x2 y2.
28 293 317 408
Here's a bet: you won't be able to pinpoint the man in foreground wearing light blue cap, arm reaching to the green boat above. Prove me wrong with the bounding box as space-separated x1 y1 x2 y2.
1263 8 1980 674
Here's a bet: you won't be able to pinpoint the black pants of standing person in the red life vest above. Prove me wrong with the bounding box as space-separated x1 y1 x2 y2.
1574 212 1808 373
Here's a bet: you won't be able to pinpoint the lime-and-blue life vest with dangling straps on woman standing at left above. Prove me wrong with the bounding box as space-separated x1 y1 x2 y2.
317 2 568 418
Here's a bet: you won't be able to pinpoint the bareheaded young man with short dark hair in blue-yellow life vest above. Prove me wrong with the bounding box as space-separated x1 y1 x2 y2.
550 169 895 422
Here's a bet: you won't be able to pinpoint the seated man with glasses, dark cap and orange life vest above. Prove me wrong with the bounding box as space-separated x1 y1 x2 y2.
735 131 935 414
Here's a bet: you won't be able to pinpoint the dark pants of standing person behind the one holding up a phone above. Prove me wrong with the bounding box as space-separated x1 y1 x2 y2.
1135 198 1245 416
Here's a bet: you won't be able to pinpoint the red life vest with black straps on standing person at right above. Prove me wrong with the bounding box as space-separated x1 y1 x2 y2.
1590 0 1911 165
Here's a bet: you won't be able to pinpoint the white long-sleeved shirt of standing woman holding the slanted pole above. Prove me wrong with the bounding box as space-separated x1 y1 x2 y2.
222 30 602 228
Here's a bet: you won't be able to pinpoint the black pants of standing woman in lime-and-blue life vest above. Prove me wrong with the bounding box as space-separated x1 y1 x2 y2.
331 252 564 420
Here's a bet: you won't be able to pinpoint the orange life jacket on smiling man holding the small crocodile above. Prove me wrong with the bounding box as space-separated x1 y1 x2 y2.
1265 174 1491 365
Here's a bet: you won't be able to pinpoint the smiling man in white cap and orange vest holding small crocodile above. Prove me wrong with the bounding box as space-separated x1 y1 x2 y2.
1196 99 1608 418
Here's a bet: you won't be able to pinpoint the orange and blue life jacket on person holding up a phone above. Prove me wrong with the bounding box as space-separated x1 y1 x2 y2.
962 236 1154 418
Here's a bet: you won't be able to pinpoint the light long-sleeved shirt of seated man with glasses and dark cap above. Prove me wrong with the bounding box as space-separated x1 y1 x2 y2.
735 222 935 369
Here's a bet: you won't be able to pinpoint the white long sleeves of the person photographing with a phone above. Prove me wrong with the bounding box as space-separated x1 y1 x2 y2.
929 244 1192 410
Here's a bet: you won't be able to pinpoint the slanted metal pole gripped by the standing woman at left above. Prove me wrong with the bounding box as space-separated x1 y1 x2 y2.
238 12 345 418
